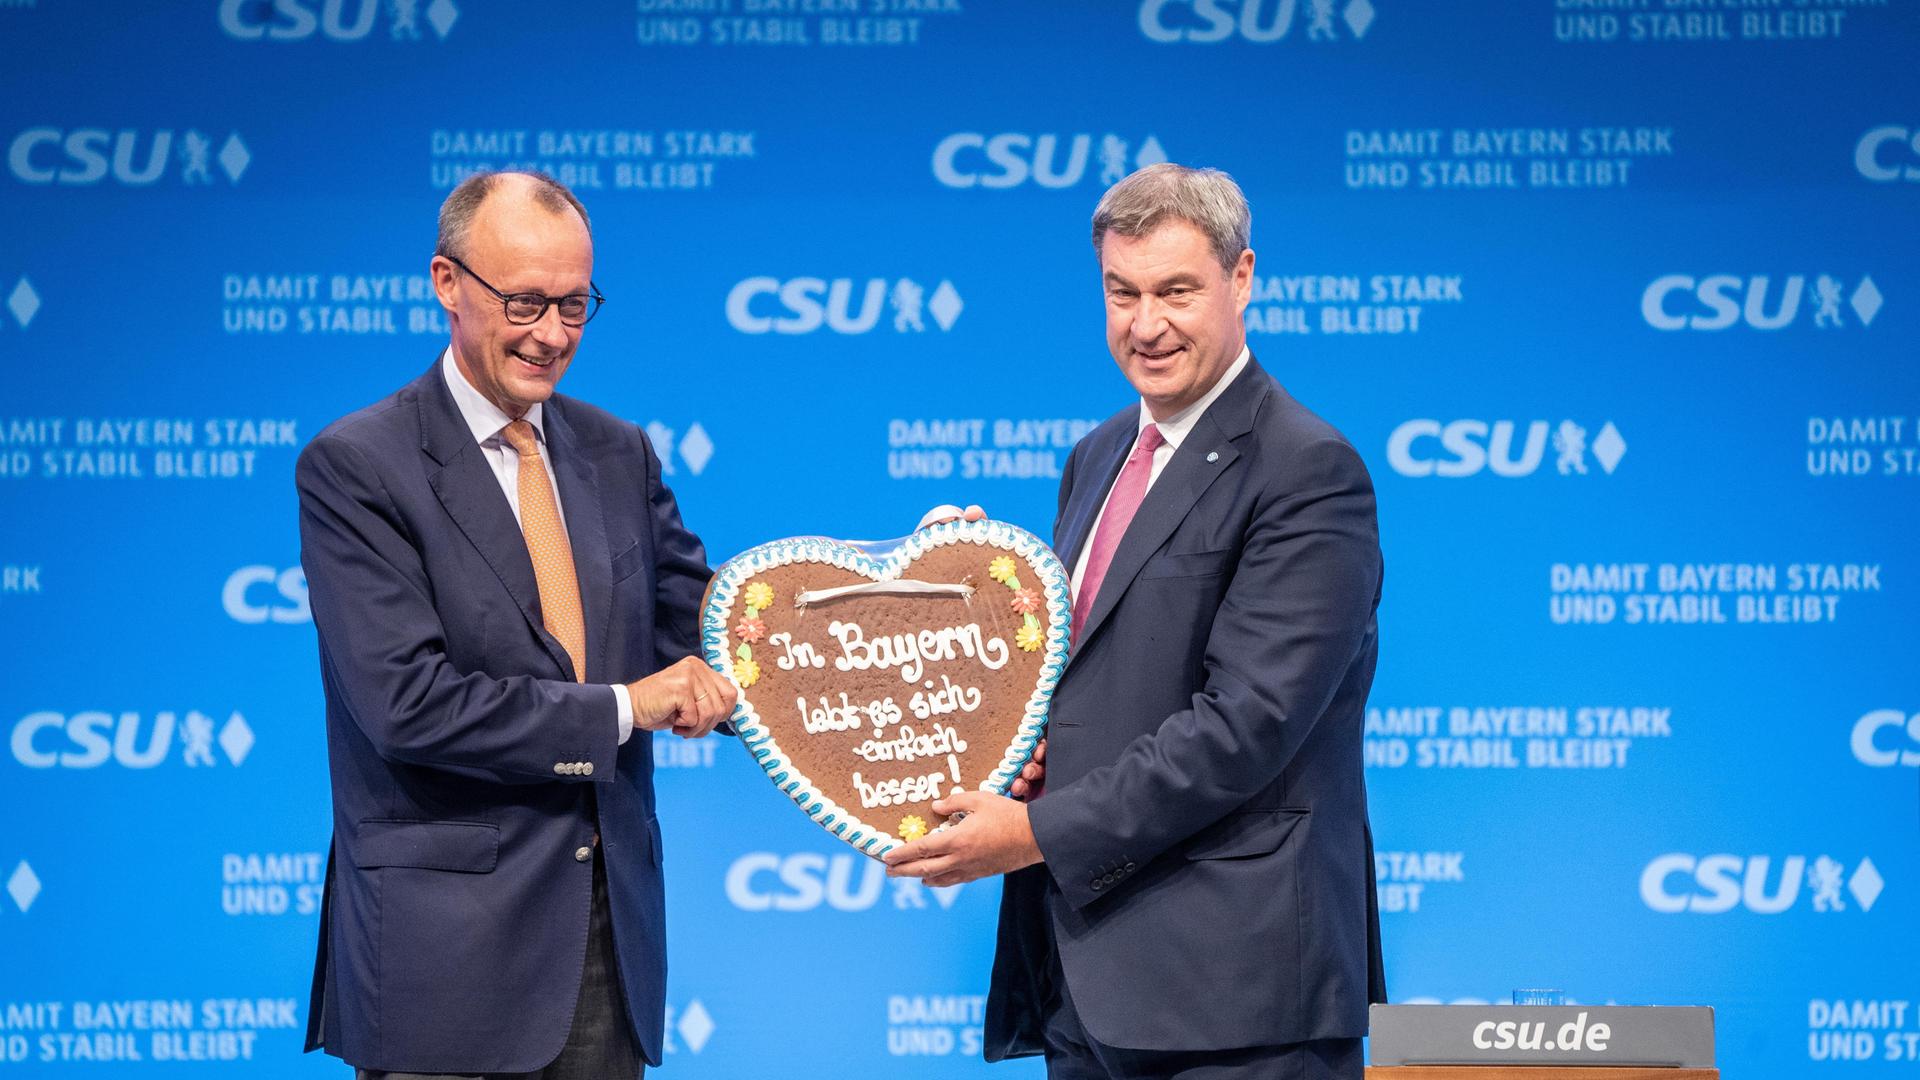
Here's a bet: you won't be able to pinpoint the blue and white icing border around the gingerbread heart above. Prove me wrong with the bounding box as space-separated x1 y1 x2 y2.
701 521 1071 857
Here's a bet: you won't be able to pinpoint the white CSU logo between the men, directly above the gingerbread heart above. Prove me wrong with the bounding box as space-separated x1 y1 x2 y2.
726 277 962 334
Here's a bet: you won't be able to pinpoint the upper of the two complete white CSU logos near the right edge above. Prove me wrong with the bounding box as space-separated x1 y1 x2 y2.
1640 273 1884 331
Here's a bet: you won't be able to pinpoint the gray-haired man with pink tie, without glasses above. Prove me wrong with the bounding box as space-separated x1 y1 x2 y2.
887 163 1384 1080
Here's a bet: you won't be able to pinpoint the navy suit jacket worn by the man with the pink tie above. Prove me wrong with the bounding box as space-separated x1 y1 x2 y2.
985 361 1384 1061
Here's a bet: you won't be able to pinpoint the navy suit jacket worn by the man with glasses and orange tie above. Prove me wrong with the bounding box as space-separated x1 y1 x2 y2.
296 359 708 1072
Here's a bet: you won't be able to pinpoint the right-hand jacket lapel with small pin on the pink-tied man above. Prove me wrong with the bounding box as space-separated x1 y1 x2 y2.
1073 359 1271 648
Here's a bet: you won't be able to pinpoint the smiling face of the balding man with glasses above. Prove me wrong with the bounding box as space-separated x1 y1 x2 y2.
432 177 593 419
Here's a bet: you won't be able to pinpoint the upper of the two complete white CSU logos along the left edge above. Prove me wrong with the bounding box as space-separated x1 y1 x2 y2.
6 127 253 188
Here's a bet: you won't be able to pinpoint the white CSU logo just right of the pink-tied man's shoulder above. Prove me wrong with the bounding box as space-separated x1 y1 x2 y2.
1386 419 1626 477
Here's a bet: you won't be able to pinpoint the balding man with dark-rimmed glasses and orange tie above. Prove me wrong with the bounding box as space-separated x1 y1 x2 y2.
296 173 733 1080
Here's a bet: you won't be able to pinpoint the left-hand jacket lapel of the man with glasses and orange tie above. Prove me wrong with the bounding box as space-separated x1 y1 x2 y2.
415 359 568 673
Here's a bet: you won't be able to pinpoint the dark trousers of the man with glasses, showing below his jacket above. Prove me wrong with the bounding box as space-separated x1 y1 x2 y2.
359 844 645 1080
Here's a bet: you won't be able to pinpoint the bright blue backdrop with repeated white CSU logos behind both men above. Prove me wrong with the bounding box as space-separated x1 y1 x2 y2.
0 0 1920 1080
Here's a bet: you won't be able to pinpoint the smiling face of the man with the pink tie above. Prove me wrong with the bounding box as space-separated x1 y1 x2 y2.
1100 219 1254 421
